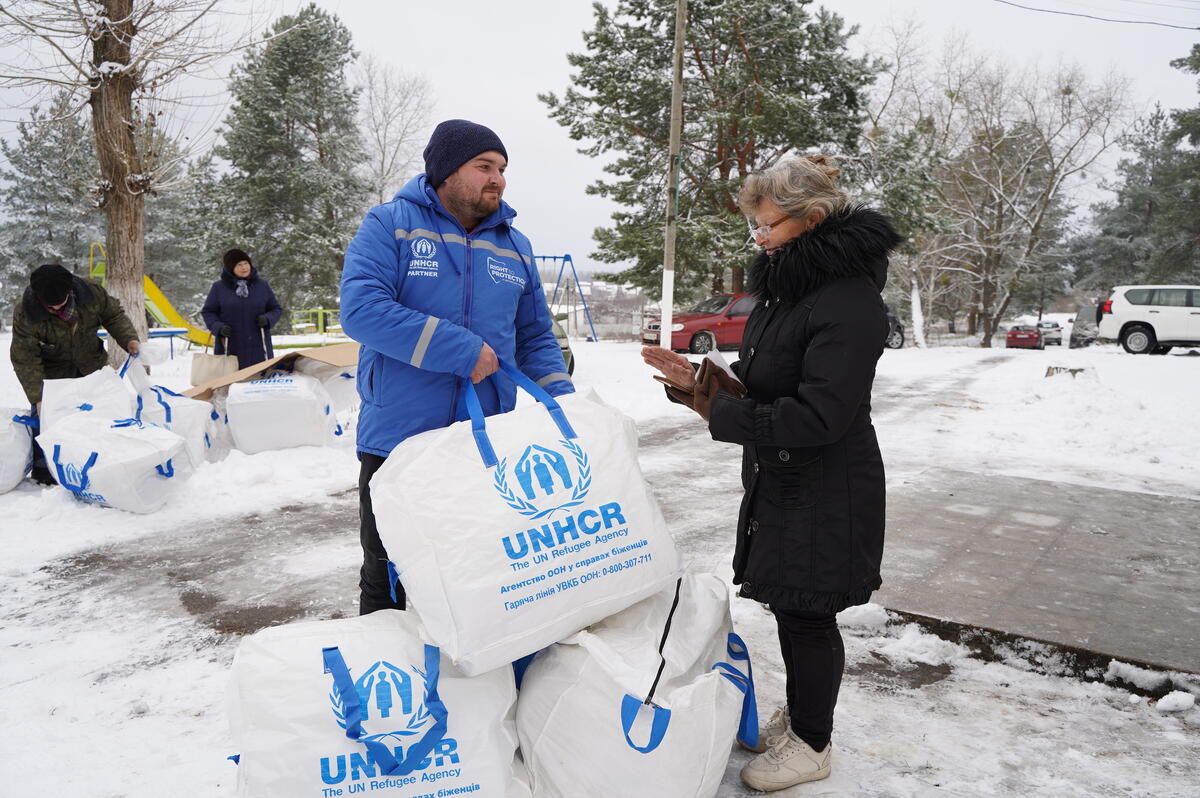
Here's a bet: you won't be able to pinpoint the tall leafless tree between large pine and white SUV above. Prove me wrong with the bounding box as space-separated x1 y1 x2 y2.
874 36 1129 347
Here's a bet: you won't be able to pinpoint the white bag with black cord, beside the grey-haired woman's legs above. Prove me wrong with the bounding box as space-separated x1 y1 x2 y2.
517 574 758 798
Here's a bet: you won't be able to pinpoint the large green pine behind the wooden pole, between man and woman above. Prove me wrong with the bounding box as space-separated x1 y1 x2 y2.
541 0 874 296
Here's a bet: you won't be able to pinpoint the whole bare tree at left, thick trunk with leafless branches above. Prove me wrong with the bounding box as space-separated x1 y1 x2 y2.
0 0 284 358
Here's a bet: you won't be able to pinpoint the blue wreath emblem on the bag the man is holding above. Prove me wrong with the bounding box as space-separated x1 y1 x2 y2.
493 440 592 518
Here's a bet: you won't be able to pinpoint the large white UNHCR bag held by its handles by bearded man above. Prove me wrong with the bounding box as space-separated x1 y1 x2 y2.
371 361 679 673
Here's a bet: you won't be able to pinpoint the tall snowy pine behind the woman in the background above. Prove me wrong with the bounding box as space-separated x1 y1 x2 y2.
212 5 367 310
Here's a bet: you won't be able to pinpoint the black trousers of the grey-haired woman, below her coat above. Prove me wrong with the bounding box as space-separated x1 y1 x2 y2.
774 610 846 751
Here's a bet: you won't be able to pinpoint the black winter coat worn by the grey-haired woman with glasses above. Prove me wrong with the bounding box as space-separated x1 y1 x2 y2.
709 208 901 613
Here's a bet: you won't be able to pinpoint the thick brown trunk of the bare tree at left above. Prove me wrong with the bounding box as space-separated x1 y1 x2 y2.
91 0 149 365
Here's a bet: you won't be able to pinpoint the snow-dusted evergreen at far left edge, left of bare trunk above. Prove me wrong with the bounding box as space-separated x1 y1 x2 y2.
0 92 104 301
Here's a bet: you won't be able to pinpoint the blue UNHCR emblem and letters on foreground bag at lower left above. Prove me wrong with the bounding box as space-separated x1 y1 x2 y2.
320 661 458 792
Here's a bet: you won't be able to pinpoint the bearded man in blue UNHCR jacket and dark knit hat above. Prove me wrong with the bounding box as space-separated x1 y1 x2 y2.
341 119 575 614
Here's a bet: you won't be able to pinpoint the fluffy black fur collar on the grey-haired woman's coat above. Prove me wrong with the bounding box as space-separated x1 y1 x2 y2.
746 205 904 302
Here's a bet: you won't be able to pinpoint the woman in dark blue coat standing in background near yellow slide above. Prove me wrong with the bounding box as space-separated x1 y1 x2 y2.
200 250 283 368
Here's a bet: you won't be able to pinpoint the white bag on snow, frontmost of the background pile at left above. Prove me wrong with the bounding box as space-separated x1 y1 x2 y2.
37 412 192 512
